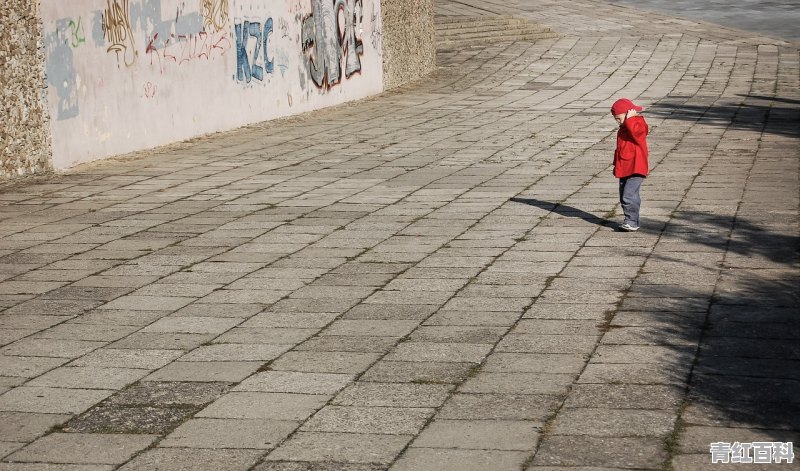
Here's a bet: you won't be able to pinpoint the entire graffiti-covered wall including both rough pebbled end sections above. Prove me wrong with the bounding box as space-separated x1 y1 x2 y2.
0 0 435 177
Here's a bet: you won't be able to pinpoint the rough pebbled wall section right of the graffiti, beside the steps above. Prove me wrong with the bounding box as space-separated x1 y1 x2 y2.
381 0 436 89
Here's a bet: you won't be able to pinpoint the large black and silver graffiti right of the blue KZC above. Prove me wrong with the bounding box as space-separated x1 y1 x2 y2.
301 0 364 89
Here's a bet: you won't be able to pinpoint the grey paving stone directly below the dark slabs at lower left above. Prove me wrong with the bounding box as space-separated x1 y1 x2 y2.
9 433 156 464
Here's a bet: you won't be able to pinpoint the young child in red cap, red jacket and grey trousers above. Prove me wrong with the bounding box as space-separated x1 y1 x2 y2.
611 98 650 232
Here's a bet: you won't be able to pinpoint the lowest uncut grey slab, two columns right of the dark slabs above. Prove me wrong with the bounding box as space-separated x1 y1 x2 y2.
266 432 412 465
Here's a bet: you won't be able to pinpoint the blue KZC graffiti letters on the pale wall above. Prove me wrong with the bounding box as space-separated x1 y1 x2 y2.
234 18 275 83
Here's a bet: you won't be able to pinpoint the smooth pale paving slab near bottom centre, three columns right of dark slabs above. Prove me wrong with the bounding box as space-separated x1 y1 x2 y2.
411 420 540 451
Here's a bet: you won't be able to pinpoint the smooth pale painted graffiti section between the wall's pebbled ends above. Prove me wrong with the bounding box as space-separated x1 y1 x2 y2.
41 0 383 169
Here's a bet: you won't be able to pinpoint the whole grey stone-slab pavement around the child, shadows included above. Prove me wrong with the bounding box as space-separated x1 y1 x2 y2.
0 0 800 471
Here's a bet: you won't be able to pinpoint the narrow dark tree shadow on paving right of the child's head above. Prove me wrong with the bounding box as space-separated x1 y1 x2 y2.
647 95 800 137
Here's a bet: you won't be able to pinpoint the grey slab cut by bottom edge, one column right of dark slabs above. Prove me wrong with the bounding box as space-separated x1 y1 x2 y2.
119 448 263 471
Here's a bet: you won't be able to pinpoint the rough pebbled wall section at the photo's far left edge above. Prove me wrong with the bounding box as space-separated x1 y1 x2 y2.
0 0 50 178
